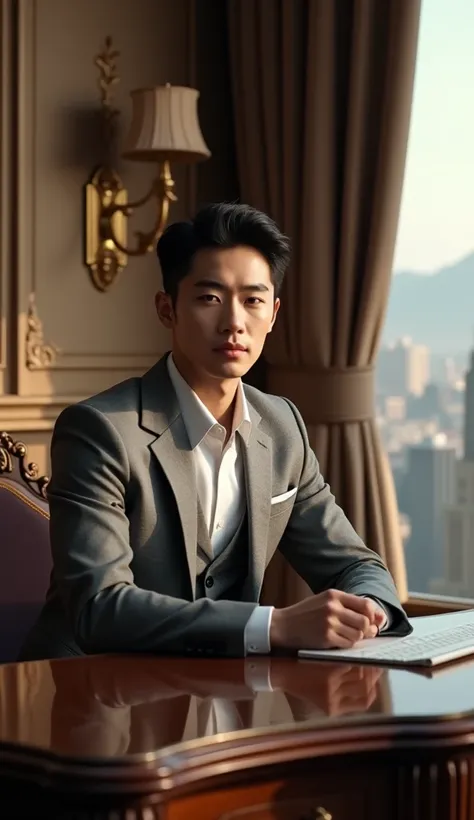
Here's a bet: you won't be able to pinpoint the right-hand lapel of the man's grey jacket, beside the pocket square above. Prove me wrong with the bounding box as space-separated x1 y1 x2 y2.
243 404 272 601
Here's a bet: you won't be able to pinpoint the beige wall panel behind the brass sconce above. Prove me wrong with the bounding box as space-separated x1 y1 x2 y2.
14 0 195 403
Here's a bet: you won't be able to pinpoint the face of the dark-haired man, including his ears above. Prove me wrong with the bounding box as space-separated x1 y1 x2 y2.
156 247 280 381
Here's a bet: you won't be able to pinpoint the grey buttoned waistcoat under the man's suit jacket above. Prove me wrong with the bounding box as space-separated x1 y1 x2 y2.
196 502 249 601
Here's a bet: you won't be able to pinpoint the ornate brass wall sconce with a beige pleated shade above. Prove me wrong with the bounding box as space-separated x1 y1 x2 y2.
85 37 211 291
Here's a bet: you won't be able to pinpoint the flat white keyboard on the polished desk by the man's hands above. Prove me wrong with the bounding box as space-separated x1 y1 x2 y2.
298 623 474 666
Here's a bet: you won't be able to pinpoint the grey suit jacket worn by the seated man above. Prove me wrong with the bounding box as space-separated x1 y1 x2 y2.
21 357 410 660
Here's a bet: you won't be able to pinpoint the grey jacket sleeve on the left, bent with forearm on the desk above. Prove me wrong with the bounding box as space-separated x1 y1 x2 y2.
48 404 256 657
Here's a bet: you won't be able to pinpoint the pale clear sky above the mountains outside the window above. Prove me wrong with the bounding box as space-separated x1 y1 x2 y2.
394 0 474 273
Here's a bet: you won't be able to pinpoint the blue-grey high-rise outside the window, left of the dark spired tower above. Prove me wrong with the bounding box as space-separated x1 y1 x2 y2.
403 434 456 592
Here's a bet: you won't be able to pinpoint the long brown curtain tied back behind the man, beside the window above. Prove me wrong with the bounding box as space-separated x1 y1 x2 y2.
228 0 420 605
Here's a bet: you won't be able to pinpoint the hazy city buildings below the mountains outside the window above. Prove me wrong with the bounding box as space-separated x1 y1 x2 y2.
376 340 474 598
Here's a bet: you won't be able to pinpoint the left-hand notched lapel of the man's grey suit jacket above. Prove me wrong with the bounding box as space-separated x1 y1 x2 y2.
141 356 198 599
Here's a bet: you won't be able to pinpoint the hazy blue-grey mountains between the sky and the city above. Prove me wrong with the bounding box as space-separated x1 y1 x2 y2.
383 253 474 356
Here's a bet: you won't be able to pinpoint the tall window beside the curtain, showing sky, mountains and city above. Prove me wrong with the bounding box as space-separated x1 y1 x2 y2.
377 0 474 598
